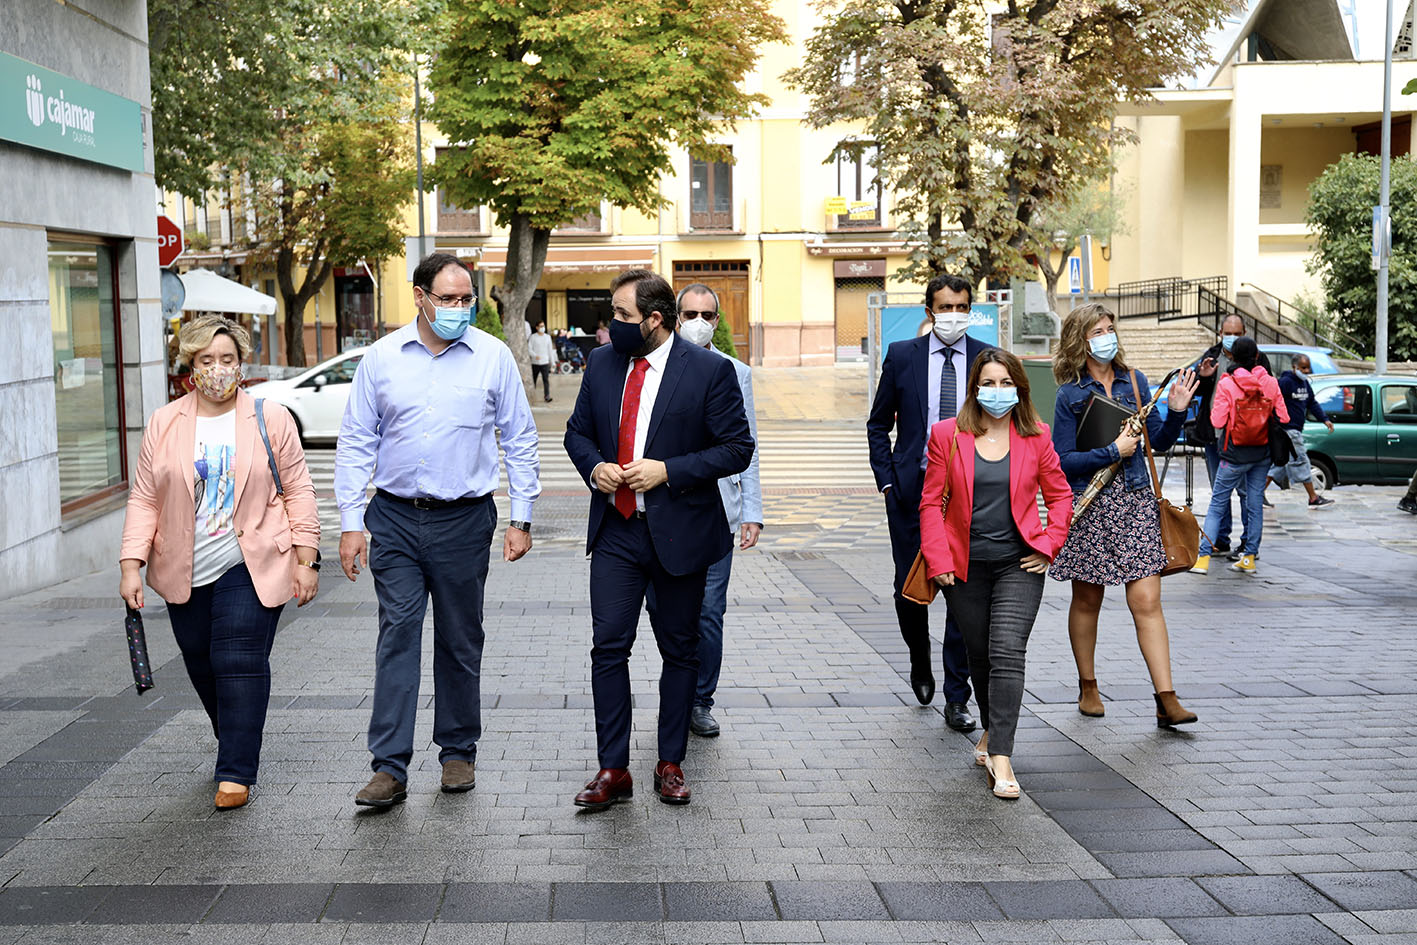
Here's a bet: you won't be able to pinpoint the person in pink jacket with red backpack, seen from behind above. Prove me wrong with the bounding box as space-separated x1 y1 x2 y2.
1192 336 1289 574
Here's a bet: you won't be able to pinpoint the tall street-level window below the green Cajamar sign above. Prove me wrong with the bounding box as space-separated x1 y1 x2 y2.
50 239 125 513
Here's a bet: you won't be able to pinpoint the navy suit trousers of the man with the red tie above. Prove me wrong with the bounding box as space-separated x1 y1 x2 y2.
591 510 707 768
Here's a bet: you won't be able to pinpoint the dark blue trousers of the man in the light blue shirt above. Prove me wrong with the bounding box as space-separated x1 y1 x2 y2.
364 496 497 783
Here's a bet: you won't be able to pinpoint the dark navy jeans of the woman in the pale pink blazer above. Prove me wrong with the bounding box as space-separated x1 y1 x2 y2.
167 564 283 785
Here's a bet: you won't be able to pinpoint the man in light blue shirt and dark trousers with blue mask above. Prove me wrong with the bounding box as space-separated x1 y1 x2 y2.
334 252 541 809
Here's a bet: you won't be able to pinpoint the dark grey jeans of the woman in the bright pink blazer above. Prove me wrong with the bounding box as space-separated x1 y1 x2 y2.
945 558 1043 755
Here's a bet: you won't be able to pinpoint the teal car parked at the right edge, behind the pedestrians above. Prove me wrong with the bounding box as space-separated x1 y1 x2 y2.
1304 374 1417 489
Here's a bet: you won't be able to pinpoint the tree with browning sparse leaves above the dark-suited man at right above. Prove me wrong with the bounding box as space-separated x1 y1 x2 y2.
786 0 1237 289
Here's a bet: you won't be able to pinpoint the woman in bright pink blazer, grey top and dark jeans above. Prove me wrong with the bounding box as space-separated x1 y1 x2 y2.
920 349 1073 798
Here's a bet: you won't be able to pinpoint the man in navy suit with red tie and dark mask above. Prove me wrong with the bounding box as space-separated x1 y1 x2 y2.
565 269 754 810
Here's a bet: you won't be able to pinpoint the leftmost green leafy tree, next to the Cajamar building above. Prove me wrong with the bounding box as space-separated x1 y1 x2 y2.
149 0 431 364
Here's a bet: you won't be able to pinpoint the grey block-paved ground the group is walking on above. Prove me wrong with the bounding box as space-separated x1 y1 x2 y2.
0 370 1417 945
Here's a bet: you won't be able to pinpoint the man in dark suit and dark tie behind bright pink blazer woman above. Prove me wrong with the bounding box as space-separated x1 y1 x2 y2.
866 275 989 731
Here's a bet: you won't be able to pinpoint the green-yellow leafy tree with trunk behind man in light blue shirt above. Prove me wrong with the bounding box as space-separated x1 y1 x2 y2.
428 0 785 384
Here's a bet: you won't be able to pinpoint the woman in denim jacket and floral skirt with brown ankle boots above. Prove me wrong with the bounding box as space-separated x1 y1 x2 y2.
1049 303 1196 727
